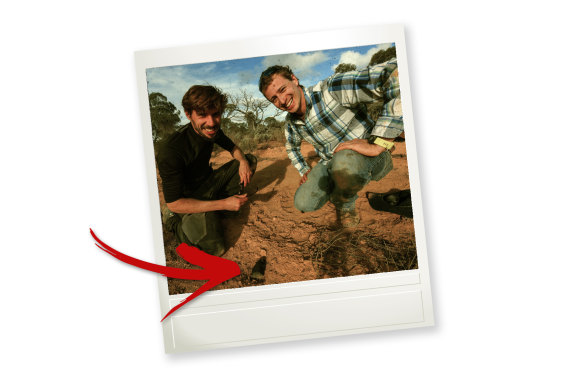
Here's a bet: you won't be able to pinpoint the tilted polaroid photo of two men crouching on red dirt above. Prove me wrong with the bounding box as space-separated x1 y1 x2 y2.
136 25 434 353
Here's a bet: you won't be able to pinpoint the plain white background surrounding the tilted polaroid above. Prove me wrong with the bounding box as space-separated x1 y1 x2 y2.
0 0 584 388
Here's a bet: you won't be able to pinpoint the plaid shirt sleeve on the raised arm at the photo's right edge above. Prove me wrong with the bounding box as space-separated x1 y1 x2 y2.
328 58 404 138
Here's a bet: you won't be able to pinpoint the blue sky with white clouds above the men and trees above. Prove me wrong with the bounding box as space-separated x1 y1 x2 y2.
146 43 393 123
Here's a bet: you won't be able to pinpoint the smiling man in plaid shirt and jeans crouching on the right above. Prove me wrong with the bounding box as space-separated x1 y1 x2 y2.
259 59 403 227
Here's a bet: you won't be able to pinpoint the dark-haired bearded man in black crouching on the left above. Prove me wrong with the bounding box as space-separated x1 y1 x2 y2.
157 85 257 256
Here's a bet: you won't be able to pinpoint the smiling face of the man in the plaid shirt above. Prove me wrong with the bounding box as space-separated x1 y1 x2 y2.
264 74 306 115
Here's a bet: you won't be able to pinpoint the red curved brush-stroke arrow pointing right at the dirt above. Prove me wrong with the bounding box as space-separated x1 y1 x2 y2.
89 228 241 321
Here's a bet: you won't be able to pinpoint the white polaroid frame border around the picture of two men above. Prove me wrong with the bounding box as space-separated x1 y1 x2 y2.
135 25 434 353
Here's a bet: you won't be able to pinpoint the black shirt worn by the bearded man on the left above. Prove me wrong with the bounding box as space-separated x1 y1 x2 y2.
157 123 235 203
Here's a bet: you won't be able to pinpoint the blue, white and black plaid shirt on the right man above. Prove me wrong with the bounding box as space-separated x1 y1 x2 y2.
285 58 403 176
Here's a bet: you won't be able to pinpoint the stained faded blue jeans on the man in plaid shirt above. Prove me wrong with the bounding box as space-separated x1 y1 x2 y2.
294 150 393 212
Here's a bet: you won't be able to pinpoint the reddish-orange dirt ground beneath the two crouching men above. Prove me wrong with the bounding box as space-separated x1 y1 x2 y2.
159 142 417 294
